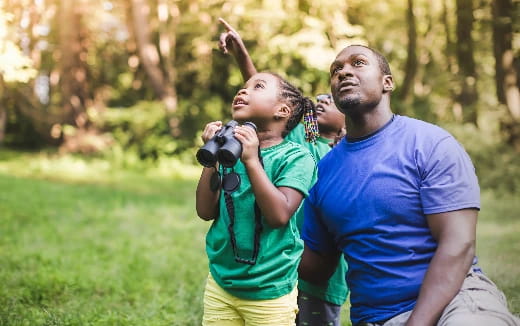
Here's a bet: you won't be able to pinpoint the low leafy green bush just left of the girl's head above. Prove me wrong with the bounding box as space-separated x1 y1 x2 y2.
90 96 230 167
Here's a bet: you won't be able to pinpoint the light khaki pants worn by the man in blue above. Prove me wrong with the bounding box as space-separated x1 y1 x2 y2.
356 271 520 326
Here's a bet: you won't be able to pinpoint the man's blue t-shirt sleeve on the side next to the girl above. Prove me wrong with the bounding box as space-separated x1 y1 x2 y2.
301 188 337 252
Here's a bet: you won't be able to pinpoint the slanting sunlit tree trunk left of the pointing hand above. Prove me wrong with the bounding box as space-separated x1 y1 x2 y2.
131 0 177 112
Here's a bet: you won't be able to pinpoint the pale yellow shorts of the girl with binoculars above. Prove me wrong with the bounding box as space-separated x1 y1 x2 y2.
202 274 298 326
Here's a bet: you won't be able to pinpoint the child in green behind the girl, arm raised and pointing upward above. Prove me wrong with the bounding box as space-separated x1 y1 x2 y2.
218 18 348 326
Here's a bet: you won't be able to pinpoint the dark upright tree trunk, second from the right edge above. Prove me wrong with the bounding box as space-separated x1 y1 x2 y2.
456 0 478 124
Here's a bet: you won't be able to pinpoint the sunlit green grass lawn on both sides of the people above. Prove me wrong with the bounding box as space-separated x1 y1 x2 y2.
0 152 520 326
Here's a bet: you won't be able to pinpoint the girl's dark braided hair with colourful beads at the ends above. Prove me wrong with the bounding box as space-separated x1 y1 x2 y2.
270 73 320 143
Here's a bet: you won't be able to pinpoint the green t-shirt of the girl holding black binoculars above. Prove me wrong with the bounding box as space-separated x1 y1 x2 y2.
206 140 316 300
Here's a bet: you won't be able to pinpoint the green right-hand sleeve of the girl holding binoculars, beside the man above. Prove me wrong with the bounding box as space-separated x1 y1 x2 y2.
273 145 317 197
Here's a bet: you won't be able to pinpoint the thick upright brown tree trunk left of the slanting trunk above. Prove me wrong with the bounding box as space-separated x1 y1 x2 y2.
60 0 88 128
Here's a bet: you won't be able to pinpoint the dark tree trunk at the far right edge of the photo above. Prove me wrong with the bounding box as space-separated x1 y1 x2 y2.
493 0 520 121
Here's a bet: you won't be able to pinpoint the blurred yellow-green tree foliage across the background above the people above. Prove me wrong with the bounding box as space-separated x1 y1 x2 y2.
0 0 520 167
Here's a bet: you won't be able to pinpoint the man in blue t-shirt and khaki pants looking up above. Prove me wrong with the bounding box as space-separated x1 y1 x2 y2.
299 46 518 326
